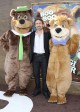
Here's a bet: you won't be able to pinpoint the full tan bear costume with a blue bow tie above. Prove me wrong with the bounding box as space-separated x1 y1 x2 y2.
46 15 79 104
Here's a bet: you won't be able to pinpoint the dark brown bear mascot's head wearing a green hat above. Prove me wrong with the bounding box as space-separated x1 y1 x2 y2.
10 6 33 34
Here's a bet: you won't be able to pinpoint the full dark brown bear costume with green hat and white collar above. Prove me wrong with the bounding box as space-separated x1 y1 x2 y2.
0 6 33 96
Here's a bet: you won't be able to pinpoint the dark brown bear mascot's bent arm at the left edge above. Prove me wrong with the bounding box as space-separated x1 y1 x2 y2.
0 31 9 51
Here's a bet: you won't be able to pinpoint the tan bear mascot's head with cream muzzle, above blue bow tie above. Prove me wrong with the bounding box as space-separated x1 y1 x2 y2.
49 15 72 41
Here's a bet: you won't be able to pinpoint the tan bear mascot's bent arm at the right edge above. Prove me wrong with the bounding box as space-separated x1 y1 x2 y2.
67 34 80 54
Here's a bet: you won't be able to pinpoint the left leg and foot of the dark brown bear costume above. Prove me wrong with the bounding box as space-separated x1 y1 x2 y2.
4 55 18 96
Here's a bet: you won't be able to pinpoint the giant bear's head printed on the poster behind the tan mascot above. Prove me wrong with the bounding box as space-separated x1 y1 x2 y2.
36 4 80 36
